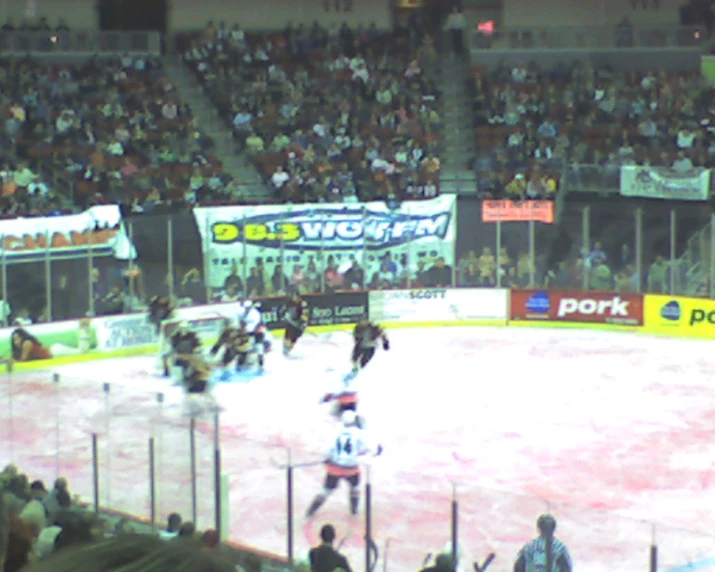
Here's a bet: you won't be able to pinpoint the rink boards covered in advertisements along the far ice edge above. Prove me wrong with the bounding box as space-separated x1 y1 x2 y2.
0 288 715 369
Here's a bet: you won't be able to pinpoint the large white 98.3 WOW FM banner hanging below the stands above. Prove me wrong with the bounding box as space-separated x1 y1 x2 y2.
194 195 457 288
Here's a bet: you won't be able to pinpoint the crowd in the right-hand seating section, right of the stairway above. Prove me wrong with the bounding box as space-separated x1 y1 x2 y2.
470 62 715 199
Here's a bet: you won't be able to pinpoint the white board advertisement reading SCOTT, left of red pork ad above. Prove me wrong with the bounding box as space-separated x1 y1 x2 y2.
369 288 509 324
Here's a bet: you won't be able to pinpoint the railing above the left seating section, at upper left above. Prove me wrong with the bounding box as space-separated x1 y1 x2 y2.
0 30 161 56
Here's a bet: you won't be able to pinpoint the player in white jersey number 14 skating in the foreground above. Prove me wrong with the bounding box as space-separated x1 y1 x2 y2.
306 411 382 518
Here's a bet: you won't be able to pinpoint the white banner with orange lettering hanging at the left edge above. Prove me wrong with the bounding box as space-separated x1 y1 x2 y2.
0 205 136 260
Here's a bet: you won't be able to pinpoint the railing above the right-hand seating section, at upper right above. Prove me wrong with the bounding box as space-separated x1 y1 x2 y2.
471 25 708 50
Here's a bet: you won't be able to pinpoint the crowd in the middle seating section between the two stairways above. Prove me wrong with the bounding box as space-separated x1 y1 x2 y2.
179 19 441 203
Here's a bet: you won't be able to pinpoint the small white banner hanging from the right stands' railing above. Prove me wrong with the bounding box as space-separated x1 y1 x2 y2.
621 165 710 201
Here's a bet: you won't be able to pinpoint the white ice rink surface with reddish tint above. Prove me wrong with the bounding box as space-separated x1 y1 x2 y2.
0 328 715 572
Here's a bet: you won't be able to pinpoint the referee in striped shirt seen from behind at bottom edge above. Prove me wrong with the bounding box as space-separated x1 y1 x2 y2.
514 514 573 572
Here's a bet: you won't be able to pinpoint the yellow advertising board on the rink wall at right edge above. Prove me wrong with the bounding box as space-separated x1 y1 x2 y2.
643 295 715 339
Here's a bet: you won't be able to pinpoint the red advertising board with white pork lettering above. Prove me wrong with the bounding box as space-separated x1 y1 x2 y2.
510 290 643 326
